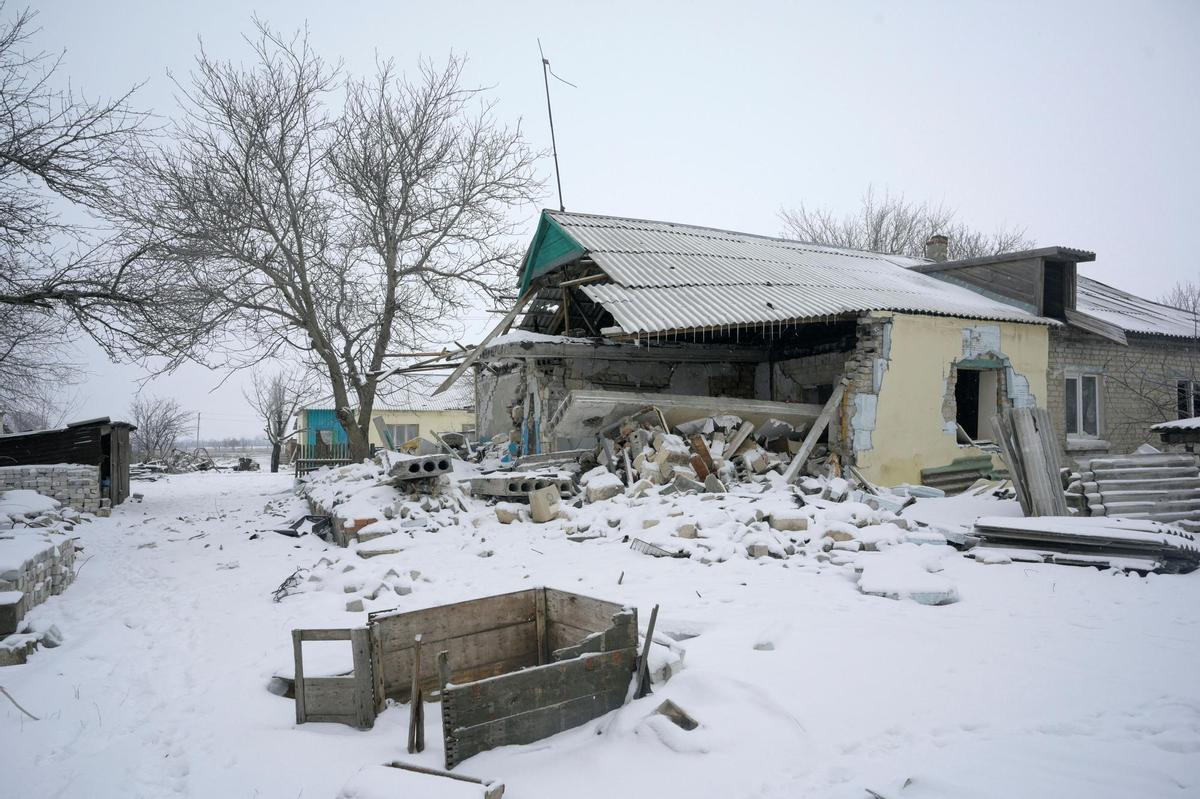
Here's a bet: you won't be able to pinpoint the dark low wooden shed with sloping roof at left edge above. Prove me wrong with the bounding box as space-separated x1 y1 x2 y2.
0 416 137 505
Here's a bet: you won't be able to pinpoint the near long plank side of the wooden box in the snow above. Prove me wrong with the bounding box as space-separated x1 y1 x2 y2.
442 648 636 768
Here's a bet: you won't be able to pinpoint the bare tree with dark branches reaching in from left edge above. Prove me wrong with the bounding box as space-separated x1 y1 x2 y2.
0 5 168 386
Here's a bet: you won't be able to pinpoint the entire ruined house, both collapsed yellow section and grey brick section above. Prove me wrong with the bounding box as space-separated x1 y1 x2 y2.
451 211 1200 485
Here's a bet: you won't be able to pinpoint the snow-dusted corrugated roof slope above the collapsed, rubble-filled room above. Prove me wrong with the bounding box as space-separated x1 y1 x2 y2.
545 211 1054 334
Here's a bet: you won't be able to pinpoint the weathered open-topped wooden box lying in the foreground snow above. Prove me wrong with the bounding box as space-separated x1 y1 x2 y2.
293 588 637 769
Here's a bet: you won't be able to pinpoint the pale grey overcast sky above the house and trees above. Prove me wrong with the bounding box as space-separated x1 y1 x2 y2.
28 0 1200 438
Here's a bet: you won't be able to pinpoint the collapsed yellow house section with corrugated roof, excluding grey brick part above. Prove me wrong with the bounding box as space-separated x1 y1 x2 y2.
458 211 1057 485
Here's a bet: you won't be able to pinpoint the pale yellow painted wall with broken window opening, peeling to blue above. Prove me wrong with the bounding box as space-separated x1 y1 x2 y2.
846 313 1049 486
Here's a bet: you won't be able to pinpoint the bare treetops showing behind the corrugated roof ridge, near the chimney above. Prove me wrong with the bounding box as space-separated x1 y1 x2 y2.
779 187 1036 260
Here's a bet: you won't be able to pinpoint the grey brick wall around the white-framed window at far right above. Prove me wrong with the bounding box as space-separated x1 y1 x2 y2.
1046 328 1200 457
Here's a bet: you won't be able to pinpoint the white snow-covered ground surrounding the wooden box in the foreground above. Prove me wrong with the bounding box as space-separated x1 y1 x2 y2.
0 473 1200 799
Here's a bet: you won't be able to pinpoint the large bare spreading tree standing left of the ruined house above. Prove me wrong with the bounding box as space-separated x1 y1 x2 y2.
120 23 539 457
